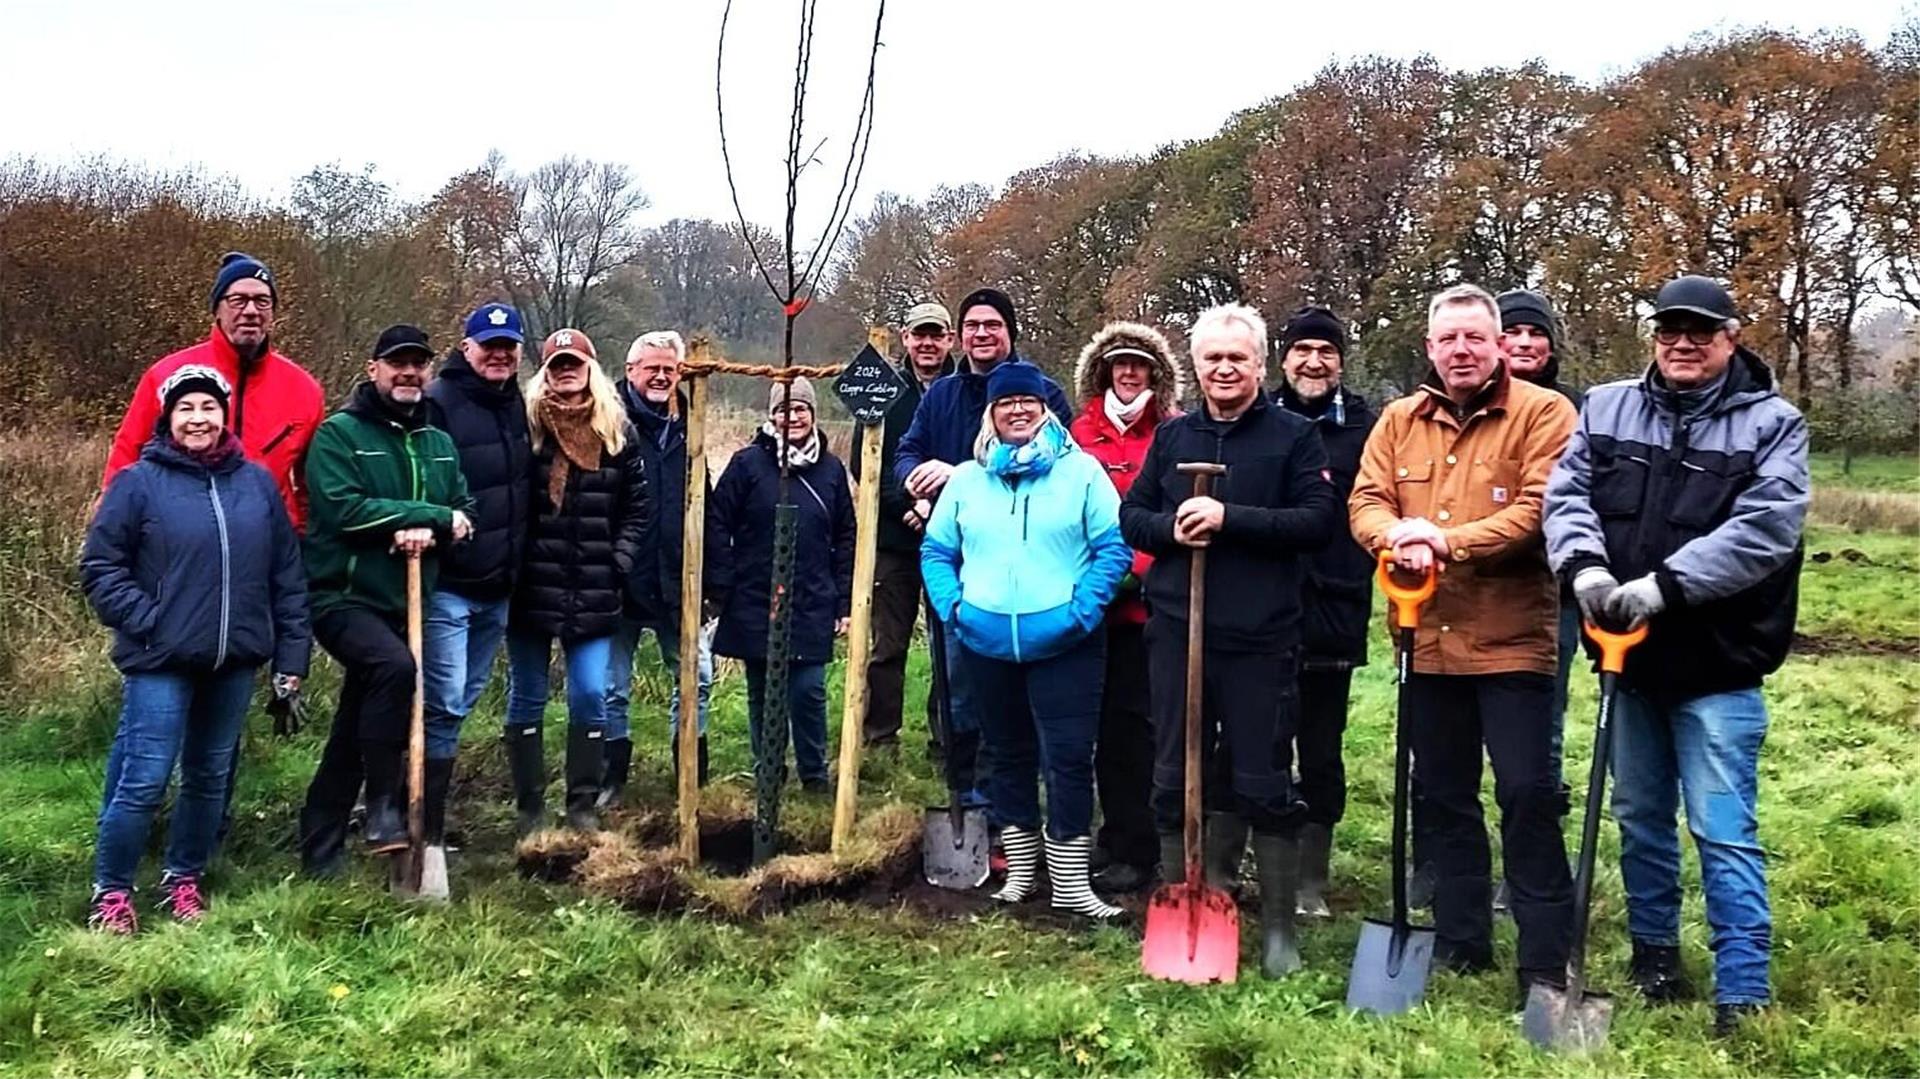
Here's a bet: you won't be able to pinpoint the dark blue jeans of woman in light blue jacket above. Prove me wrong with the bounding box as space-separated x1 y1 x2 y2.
962 630 1105 839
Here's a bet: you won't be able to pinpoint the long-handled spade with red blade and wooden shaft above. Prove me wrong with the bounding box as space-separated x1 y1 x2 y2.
1140 463 1240 985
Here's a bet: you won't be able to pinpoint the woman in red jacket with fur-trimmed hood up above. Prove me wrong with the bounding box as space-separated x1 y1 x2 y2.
1069 323 1187 893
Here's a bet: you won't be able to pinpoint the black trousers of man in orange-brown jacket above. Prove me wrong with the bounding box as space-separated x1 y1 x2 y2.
1407 672 1572 977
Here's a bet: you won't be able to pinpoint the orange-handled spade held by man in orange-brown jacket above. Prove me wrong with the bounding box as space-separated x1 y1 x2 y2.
1346 551 1438 1016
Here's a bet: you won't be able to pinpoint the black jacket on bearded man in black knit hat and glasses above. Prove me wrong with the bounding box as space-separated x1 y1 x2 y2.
1279 384 1380 670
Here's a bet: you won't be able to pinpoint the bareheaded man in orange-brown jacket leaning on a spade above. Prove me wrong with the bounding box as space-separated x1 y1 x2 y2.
1348 284 1574 1000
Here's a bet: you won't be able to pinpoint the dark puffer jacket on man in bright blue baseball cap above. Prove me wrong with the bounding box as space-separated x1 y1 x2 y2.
426 351 534 603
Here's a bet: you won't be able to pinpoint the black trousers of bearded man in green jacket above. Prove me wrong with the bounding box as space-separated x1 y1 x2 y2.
307 609 413 820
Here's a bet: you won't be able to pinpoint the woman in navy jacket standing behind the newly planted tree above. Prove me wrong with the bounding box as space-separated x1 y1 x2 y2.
707 378 852 793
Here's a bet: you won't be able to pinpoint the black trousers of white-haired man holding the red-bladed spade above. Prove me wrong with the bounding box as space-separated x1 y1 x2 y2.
1146 622 1306 835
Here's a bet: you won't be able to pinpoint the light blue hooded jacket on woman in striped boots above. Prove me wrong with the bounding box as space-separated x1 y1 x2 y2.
920 442 1133 662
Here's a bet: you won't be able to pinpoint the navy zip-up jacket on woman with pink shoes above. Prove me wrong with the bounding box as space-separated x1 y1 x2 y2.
81 434 313 674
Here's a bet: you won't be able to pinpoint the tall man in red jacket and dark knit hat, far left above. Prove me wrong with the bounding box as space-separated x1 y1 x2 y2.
100 252 326 532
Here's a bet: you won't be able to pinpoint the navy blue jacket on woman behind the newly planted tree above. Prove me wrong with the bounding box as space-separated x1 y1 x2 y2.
707 432 852 662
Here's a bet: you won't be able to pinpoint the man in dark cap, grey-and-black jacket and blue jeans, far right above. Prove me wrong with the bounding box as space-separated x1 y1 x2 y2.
1546 275 1809 1035
